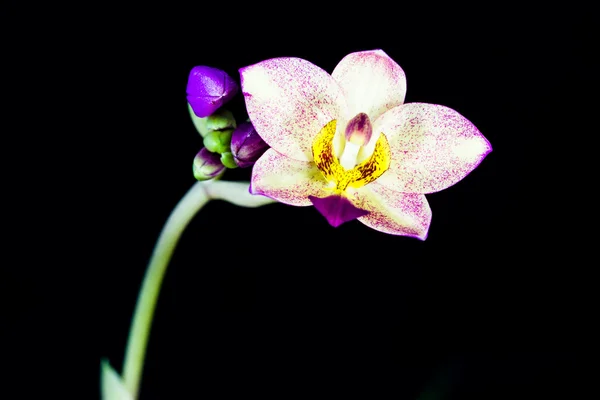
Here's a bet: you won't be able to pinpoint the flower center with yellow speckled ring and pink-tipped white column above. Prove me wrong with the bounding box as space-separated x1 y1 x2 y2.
312 113 391 192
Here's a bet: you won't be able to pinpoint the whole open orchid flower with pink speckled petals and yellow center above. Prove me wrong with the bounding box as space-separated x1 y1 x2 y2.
240 50 492 240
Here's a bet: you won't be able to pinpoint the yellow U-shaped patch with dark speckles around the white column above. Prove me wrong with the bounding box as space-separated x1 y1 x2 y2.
312 120 391 193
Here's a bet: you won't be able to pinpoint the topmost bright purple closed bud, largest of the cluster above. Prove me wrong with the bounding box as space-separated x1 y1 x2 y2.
186 65 239 118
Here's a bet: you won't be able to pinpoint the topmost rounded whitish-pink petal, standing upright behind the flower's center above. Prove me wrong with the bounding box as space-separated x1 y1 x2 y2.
331 50 406 121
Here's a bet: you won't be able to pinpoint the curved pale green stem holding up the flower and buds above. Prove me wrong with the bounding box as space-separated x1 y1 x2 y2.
123 180 274 399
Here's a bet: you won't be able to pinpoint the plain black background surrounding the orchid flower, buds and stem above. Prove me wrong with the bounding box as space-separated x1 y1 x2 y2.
0 3 597 399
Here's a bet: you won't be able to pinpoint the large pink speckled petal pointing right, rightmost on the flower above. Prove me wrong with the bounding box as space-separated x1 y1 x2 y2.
373 103 492 193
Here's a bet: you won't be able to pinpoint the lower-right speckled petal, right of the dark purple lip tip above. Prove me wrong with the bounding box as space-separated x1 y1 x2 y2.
352 182 431 240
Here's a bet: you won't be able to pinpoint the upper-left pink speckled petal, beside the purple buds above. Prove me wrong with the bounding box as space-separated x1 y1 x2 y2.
240 58 345 161
